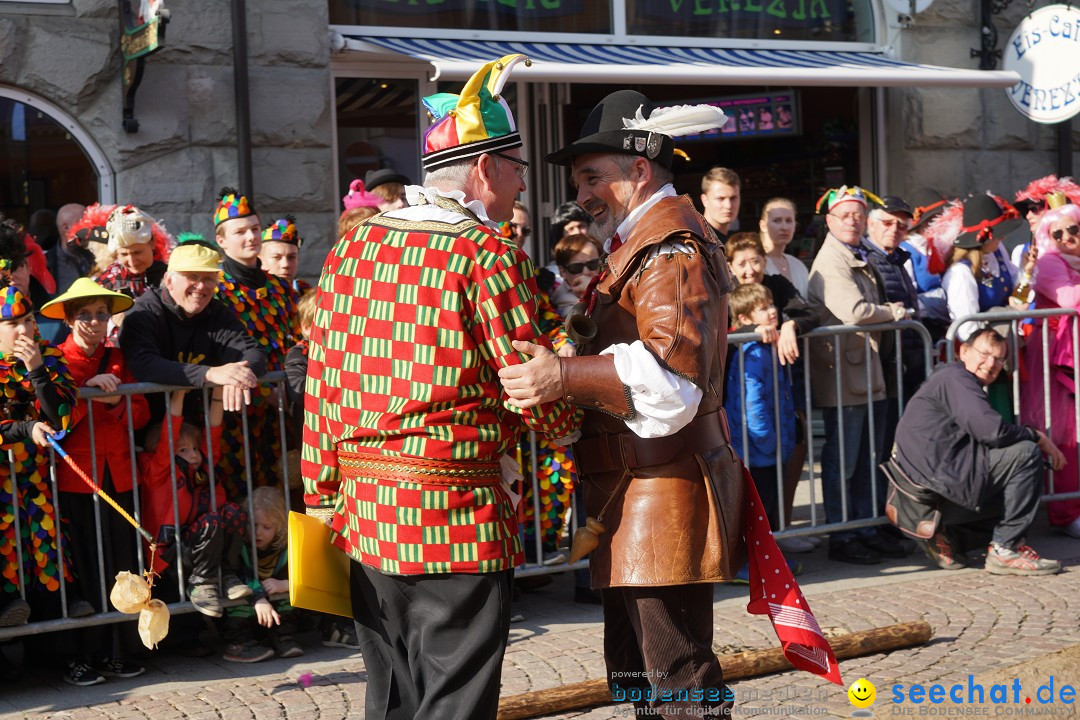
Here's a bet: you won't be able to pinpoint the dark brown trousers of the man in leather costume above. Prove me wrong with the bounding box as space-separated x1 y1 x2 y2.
600 583 732 718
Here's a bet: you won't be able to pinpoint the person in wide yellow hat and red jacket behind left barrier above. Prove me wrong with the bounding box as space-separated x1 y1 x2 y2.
41 277 150 685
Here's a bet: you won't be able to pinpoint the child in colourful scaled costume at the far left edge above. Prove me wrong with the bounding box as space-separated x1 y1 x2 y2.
0 278 78 626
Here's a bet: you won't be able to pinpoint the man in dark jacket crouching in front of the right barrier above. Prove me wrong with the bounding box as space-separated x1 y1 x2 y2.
893 328 1065 575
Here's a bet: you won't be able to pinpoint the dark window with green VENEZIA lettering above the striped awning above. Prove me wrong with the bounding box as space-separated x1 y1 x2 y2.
626 0 874 42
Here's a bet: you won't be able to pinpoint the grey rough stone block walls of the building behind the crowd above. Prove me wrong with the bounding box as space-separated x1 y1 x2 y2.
0 0 1080 279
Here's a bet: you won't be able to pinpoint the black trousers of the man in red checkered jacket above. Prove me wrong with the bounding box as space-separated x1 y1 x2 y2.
350 561 513 720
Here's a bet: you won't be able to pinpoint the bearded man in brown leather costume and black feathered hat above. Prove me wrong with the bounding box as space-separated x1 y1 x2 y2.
499 91 744 717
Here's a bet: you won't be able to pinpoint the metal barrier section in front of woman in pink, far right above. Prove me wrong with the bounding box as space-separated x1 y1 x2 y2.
944 308 1080 502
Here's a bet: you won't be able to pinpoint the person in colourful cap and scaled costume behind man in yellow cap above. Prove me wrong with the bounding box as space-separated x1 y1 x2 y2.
214 188 299 499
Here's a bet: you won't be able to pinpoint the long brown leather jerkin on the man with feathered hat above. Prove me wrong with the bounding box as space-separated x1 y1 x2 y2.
567 196 744 588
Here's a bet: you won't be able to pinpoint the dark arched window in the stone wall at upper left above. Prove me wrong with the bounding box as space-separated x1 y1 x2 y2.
0 96 99 231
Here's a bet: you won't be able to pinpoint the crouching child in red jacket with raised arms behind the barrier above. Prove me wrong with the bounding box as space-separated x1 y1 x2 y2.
139 388 252 617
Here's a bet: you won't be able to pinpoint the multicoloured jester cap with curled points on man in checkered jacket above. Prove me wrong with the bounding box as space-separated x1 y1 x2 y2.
421 55 531 171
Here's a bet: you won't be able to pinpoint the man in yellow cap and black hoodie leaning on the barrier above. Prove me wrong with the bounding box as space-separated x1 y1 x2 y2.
120 237 267 410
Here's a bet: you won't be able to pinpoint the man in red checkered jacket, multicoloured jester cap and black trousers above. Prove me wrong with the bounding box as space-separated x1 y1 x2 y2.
301 55 580 720
